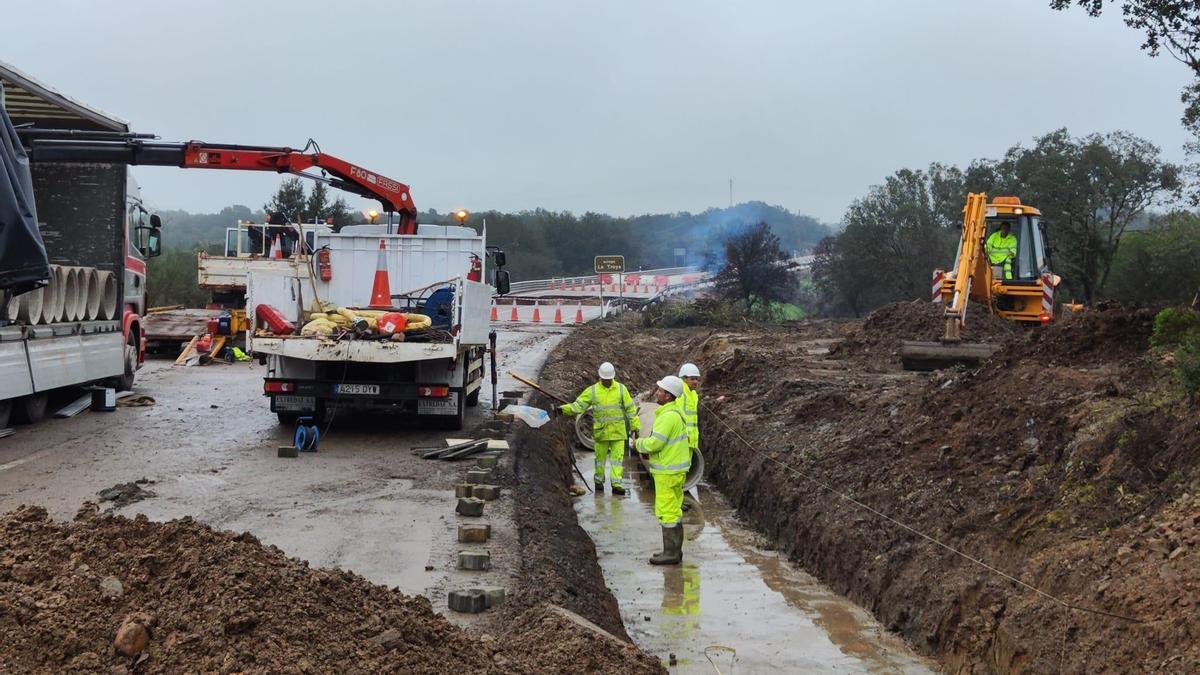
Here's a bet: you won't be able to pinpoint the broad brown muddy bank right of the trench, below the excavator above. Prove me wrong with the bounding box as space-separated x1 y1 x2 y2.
547 304 1200 673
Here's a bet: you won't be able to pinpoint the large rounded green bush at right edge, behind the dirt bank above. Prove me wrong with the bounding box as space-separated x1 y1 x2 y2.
1105 211 1200 304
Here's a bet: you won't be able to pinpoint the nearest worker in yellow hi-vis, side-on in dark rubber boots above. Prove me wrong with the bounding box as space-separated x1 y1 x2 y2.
635 375 691 565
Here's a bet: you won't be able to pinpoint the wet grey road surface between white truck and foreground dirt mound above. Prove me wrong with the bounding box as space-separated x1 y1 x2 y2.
0 327 570 623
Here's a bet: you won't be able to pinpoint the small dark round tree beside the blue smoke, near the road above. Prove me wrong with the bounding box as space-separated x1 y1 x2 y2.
713 222 794 312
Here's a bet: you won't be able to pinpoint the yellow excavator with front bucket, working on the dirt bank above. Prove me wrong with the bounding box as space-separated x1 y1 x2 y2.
900 192 1062 370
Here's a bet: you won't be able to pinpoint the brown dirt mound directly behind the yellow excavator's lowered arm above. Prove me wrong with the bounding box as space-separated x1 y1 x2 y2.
832 300 1025 366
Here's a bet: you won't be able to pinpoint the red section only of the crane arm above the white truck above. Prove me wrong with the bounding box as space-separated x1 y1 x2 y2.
180 141 416 234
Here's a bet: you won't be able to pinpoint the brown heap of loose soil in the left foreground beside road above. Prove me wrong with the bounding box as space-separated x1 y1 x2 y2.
0 507 667 673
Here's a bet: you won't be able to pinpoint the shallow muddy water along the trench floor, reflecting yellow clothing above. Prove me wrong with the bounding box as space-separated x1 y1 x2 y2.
575 444 934 674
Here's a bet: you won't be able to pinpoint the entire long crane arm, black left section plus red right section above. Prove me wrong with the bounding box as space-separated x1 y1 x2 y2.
11 129 416 234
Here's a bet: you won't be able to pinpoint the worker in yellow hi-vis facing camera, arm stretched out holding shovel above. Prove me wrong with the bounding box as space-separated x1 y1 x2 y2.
558 362 642 495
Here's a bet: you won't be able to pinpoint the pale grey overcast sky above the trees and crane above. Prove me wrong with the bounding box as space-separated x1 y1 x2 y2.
0 0 1188 222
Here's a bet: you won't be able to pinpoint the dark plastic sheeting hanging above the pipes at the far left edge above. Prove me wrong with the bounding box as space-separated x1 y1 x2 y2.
0 84 50 295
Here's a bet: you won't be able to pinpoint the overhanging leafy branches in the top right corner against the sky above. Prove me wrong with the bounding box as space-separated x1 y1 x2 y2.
1050 0 1200 203
